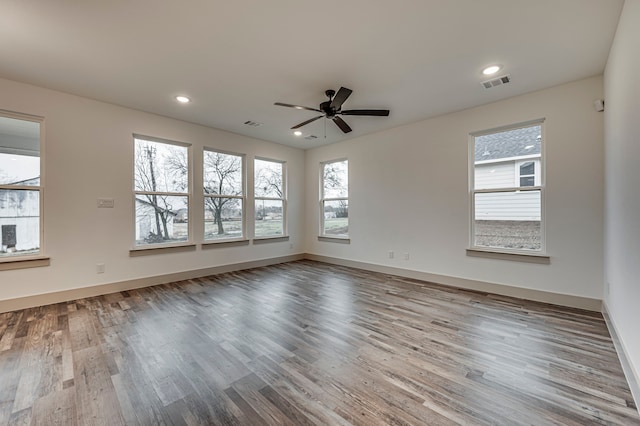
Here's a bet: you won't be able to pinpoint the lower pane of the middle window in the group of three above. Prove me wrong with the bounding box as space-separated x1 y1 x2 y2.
204 197 243 240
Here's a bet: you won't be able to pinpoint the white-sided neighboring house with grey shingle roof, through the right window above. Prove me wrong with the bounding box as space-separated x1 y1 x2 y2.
474 127 542 221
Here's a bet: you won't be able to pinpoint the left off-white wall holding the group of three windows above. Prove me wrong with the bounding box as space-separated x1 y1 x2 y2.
0 79 304 301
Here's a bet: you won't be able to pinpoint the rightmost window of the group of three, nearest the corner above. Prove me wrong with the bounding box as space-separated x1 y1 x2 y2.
253 158 286 238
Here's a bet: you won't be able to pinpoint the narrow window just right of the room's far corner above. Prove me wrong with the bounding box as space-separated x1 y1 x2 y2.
320 160 349 238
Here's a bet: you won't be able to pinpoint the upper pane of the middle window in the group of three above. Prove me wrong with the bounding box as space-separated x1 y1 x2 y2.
203 151 242 195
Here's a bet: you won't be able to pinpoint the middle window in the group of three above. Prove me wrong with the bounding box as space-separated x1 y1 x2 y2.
203 150 245 241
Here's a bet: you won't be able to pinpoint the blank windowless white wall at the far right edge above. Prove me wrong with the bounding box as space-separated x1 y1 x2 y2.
604 0 640 392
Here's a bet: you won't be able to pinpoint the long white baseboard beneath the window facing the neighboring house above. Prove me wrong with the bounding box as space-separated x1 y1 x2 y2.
305 253 602 312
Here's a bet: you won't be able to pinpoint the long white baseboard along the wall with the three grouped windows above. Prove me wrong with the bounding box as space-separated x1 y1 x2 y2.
0 254 305 313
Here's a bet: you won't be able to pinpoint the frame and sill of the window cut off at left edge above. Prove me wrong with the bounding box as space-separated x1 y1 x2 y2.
0 109 49 264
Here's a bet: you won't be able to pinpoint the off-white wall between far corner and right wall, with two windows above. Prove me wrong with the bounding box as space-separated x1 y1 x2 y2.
305 77 604 299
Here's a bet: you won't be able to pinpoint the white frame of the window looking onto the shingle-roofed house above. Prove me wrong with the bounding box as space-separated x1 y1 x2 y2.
467 118 548 255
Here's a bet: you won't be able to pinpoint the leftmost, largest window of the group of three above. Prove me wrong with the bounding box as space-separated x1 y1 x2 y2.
134 136 191 246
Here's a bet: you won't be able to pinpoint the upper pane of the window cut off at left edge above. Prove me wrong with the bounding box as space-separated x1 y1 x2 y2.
0 117 40 186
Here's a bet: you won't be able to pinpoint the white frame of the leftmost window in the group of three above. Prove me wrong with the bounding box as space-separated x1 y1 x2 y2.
130 133 194 252
